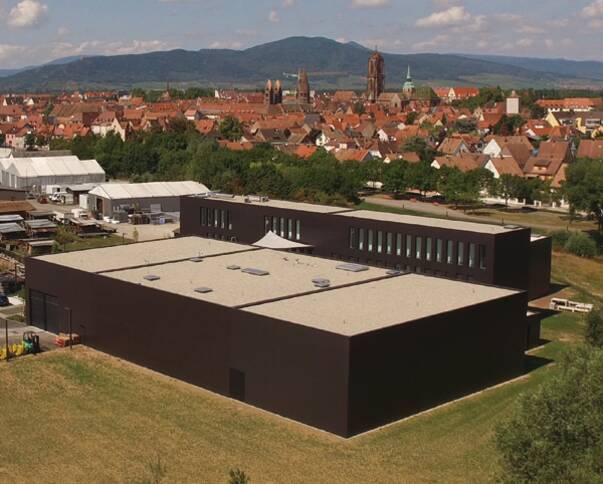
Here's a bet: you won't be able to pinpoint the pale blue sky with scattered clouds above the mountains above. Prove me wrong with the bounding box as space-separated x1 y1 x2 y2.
0 0 603 68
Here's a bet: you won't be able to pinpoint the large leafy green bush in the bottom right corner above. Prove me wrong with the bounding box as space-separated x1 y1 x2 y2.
495 345 603 483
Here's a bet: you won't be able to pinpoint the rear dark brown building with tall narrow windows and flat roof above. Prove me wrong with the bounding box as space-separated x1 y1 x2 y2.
181 195 551 299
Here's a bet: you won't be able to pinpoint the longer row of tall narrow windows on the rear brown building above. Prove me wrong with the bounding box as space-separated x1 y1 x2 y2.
349 227 486 270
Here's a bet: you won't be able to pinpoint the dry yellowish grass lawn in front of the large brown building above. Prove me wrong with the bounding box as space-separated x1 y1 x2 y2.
0 308 583 483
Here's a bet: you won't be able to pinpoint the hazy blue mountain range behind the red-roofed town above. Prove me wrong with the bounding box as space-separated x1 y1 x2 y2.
0 37 603 92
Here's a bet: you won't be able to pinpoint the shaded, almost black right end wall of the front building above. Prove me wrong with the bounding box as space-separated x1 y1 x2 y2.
349 293 527 434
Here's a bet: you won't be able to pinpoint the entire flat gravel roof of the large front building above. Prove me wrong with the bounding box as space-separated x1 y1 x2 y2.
37 237 519 336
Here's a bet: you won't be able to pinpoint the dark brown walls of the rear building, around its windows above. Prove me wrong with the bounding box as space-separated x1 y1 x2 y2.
181 197 530 290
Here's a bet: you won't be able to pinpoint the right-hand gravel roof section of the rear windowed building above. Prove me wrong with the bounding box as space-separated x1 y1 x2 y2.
336 210 521 235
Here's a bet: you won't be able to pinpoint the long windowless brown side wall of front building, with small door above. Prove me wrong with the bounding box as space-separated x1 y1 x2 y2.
27 259 348 435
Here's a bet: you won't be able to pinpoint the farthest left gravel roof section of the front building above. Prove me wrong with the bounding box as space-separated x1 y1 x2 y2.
38 237 253 272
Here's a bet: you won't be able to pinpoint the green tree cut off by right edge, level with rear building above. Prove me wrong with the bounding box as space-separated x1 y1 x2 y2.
563 159 603 231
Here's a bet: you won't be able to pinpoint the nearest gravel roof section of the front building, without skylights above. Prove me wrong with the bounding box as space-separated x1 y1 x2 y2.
245 274 517 336
